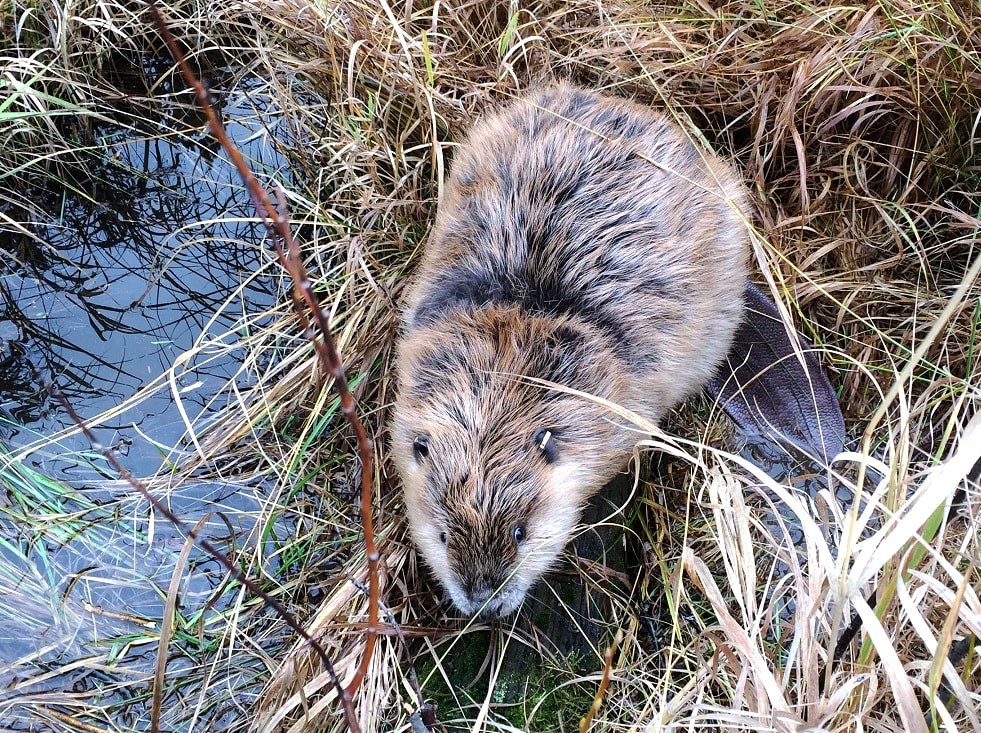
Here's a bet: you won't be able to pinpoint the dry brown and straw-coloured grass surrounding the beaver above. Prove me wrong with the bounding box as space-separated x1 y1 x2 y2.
0 0 981 731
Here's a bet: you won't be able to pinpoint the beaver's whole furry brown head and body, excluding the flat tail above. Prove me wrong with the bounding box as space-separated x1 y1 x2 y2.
391 83 751 618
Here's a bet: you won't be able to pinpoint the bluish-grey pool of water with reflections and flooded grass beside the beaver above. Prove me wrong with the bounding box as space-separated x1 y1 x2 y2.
0 60 306 730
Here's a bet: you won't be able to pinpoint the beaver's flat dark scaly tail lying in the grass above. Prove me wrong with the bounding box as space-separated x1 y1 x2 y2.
706 283 846 462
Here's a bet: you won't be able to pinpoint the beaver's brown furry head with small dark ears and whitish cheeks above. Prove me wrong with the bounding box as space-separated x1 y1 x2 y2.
392 306 632 617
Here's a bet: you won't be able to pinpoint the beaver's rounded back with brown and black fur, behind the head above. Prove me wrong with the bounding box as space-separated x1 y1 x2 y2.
405 85 749 417
